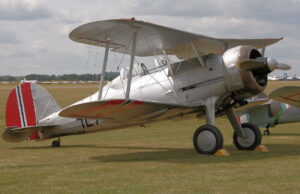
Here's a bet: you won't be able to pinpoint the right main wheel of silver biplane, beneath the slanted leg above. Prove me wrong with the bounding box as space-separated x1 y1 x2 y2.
233 123 261 150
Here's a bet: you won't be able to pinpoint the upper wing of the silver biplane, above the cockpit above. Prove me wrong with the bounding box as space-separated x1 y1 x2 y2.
69 19 282 59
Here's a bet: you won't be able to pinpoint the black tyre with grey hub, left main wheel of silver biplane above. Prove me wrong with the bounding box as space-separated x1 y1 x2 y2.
193 125 223 154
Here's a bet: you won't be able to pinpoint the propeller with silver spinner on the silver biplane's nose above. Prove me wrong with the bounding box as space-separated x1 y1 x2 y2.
239 57 291 71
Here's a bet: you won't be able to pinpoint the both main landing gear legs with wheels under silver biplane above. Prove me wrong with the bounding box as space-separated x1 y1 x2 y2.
193 98 261 154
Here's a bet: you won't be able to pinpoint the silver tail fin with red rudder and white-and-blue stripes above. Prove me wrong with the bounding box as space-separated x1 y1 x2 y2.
6 83 61 128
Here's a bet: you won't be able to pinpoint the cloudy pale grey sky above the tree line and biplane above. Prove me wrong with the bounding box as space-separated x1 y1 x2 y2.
0 0 300 76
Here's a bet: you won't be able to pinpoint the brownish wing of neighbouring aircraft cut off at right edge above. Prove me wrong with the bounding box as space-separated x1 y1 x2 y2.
269 86 300 108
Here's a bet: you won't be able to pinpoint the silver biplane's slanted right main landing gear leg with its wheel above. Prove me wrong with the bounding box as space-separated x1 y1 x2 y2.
225 107 261 150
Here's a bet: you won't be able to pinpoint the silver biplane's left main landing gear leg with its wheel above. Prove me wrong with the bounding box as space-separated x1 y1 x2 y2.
193 97 223 154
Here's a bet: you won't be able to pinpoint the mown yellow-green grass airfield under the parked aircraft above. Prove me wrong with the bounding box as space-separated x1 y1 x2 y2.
0 81 300 193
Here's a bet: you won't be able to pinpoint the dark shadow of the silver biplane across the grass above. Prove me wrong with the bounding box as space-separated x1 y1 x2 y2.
90 144 300 163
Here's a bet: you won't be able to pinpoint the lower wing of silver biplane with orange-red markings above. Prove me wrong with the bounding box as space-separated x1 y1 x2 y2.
59 100 196 123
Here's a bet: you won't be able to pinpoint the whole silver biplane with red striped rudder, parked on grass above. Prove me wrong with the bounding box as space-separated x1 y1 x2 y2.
3 18 290 154
